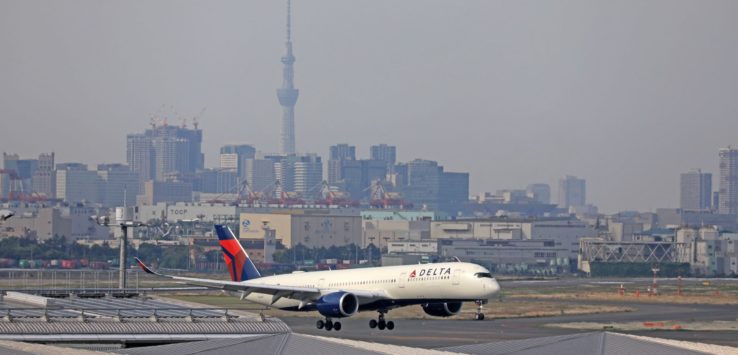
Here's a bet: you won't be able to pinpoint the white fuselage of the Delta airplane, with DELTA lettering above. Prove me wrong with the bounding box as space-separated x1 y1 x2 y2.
236 262 500 310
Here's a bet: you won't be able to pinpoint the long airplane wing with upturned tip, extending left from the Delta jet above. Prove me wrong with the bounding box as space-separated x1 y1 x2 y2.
135 258 389 303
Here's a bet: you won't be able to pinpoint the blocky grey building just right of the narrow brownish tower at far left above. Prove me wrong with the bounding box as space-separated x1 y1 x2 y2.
56 163 102 203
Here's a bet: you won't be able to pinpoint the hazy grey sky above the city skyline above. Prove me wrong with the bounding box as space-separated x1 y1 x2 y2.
0 0 738 212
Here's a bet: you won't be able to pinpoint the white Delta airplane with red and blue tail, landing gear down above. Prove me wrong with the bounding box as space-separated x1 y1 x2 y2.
136 225 500 331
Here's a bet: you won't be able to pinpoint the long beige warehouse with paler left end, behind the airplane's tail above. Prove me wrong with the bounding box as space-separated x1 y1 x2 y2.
239 209 363 248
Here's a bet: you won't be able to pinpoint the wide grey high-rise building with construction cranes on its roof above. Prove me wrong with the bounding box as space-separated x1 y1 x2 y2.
126 124 205 188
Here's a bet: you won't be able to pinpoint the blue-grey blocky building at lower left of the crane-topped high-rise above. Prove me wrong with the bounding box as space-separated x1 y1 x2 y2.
97 164 139 207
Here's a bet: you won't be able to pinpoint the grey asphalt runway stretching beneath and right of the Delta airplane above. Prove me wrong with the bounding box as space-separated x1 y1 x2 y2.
281 301 738 348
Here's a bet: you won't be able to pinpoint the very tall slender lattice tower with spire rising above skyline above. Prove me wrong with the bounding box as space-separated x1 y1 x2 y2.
277 0 299 155
